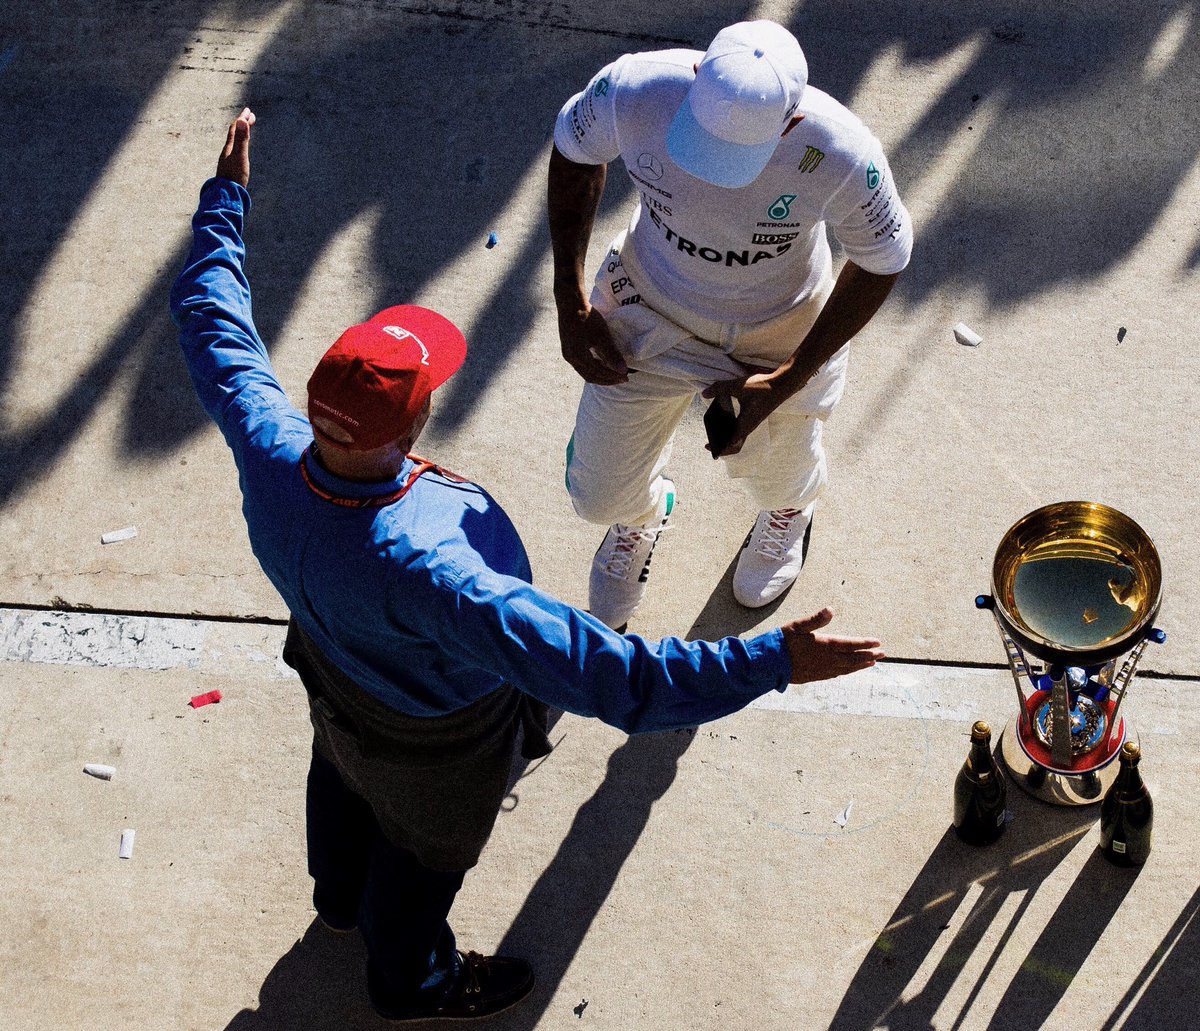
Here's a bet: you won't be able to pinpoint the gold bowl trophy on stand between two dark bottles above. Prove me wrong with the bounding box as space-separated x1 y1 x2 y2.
976 502 1166 805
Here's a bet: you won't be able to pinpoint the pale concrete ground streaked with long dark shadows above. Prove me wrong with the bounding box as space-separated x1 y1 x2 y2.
0 0 1200 1031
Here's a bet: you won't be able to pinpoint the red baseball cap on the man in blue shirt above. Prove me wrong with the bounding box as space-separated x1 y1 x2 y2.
308 305 467 451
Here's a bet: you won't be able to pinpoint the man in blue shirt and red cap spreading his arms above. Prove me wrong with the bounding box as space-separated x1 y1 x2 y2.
172 108 882 1020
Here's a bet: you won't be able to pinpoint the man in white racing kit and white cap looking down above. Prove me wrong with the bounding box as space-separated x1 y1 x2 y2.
548 22 912 628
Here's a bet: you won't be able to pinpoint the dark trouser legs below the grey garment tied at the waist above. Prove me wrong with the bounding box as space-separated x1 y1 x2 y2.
307 748 463 1009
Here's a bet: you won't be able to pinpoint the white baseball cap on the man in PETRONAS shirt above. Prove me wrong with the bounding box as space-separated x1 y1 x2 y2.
667 20 809 188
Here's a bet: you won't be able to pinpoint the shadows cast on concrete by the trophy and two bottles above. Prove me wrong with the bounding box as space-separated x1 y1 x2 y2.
829 792 1136 1031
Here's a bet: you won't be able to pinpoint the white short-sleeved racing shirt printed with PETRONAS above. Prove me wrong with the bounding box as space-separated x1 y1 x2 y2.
554 49 912 322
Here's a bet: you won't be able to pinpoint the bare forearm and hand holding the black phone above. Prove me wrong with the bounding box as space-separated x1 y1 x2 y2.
704 260 900 455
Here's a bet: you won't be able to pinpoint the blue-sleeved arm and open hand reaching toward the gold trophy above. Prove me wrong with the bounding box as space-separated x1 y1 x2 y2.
398 551 883 733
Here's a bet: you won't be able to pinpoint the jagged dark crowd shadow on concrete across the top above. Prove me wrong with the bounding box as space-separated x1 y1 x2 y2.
0 0 1200 500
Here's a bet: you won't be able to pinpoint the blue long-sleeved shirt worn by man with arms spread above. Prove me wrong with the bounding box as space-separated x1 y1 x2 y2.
170 179 791 733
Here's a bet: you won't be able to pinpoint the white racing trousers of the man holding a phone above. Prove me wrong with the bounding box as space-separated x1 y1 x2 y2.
566 234 850 526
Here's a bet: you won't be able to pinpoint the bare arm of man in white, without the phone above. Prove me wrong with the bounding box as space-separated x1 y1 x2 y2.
546 146 629 384
